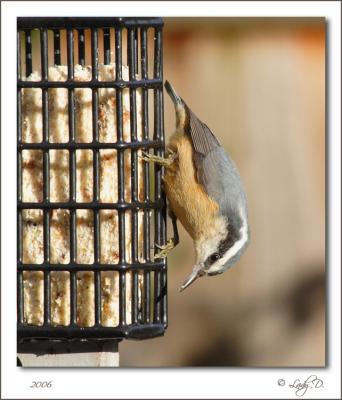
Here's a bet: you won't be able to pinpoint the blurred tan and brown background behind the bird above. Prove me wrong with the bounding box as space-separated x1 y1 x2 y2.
119 18 325 367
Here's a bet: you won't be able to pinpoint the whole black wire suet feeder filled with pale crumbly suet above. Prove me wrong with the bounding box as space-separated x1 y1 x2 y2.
17 17 167 341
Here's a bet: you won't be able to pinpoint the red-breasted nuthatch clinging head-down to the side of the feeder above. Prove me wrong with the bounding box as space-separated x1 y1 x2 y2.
143 81 249 290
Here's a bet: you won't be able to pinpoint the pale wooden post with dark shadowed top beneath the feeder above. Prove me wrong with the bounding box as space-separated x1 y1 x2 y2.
17 339 119 367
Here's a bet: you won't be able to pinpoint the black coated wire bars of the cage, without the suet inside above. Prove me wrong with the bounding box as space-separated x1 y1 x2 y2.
17 18 166 339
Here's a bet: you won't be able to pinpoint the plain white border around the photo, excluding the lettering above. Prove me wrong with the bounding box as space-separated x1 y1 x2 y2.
1 1 341 399
